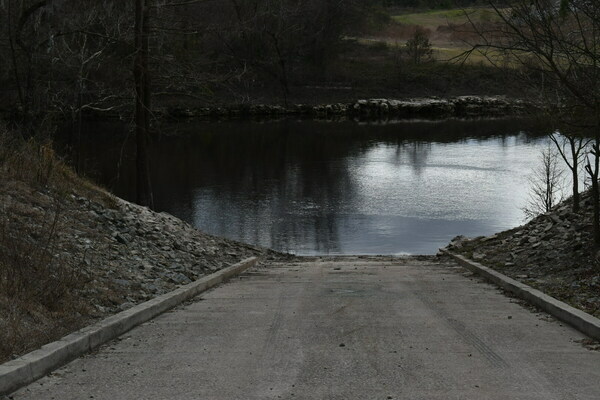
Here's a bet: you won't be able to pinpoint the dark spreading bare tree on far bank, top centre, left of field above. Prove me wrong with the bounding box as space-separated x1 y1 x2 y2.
204 0 373 102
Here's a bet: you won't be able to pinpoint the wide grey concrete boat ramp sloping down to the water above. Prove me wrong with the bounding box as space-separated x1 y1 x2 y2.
13 258 600 400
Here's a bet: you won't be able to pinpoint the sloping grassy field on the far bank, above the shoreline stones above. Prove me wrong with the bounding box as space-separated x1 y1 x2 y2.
209 9 523 104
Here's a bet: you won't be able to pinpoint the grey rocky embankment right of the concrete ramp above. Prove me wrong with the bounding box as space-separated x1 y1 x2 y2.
447 194 600 317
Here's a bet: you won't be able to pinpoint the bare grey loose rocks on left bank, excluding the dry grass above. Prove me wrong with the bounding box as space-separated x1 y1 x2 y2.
66 197 286 312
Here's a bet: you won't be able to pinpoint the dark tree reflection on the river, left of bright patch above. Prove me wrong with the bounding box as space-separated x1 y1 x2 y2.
63 120 548 253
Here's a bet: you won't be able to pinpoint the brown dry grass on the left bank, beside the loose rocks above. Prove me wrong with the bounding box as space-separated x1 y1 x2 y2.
0 127 110 361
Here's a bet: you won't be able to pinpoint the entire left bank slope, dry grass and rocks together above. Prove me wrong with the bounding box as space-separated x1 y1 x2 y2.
0 178 292 362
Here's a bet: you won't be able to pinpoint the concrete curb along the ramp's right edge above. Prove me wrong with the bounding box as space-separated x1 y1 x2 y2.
441 249 600 340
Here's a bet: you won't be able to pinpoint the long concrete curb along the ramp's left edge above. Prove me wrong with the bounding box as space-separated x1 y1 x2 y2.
0 257 258 396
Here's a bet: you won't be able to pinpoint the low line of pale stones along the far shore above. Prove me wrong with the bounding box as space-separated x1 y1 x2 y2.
162 96 535 119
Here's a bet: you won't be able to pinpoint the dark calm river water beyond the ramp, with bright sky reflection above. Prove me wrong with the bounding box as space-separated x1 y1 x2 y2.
72 119 547 255
